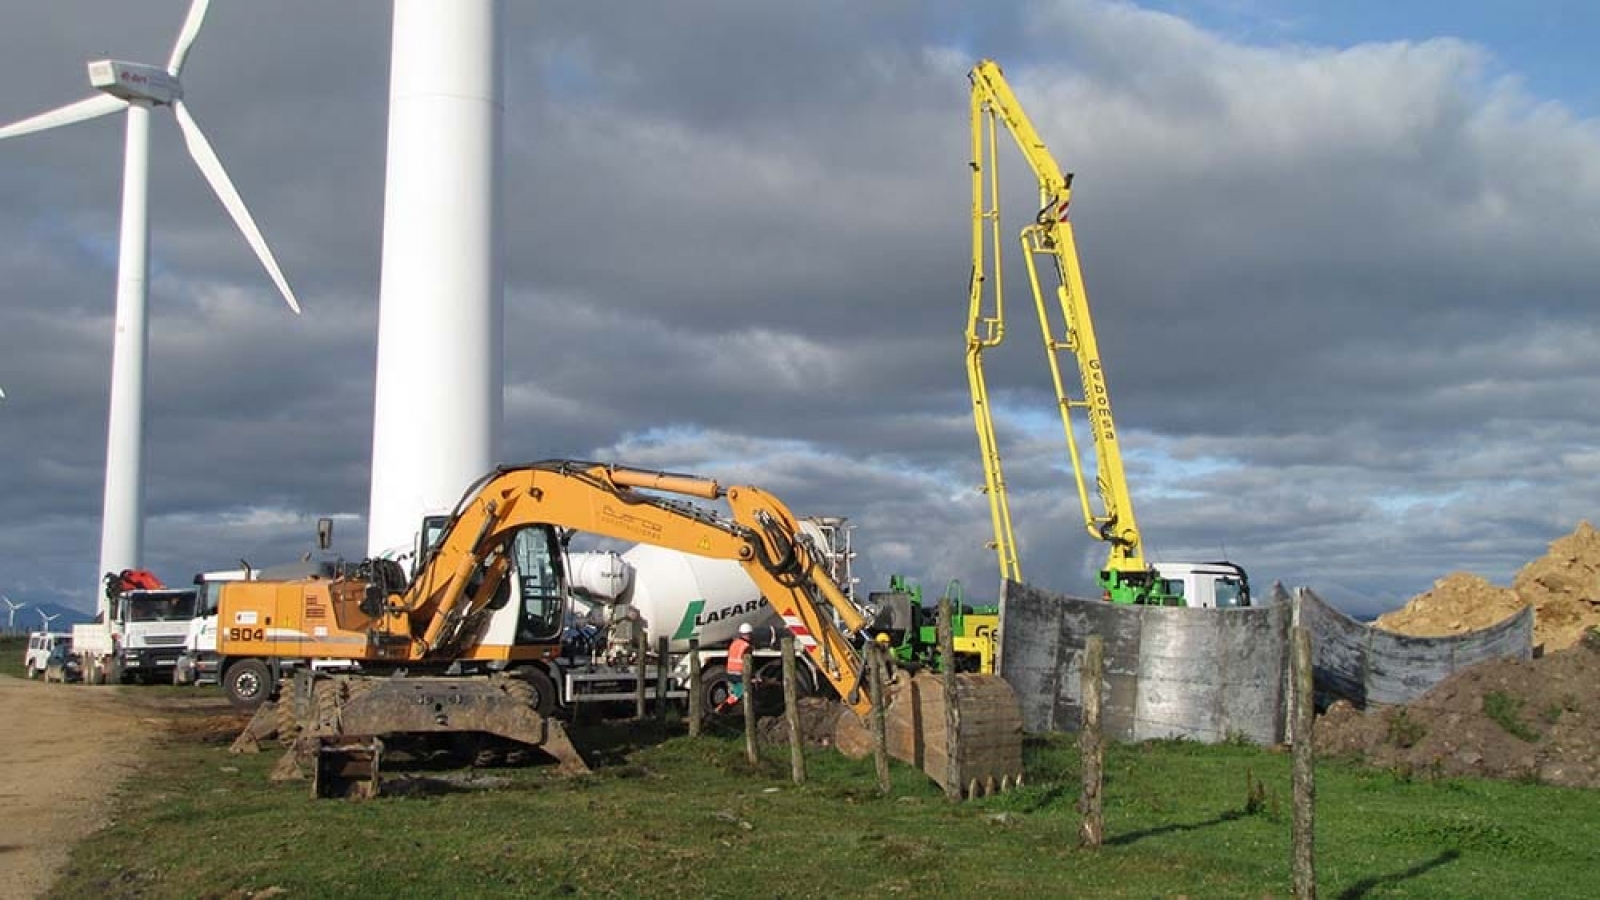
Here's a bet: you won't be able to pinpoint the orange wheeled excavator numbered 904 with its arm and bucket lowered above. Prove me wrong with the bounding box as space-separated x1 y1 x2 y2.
218 460 1021 786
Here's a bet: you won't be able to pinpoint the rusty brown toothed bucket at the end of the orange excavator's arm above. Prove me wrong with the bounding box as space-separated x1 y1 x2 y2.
835 673 1022 798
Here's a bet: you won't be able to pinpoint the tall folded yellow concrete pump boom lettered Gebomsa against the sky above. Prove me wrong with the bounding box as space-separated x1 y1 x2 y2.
966 59 1158 599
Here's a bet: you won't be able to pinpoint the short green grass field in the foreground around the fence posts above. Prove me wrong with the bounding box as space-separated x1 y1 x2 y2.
40 701 1600 898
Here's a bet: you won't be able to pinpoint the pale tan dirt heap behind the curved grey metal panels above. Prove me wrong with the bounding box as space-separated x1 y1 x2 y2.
1376 522 1600 650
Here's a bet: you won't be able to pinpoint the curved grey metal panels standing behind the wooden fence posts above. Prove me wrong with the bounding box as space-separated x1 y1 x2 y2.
998 581 1533 743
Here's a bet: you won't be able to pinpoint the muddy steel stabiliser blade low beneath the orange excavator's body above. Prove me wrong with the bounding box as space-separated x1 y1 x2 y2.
280 673 589 796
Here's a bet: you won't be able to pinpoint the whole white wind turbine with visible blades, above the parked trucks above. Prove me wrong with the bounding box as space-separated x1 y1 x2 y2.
0 0 299 605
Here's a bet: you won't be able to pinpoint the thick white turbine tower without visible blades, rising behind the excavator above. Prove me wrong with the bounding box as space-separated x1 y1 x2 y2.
366 0 504 554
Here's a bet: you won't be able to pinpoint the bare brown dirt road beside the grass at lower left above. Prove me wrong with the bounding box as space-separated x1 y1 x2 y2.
0 676 163 898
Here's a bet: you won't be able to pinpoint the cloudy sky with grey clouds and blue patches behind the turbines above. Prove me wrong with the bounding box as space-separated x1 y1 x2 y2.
0 0 1600 613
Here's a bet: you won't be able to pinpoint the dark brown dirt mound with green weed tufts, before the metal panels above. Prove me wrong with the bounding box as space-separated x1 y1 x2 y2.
1315 634 1600 788
